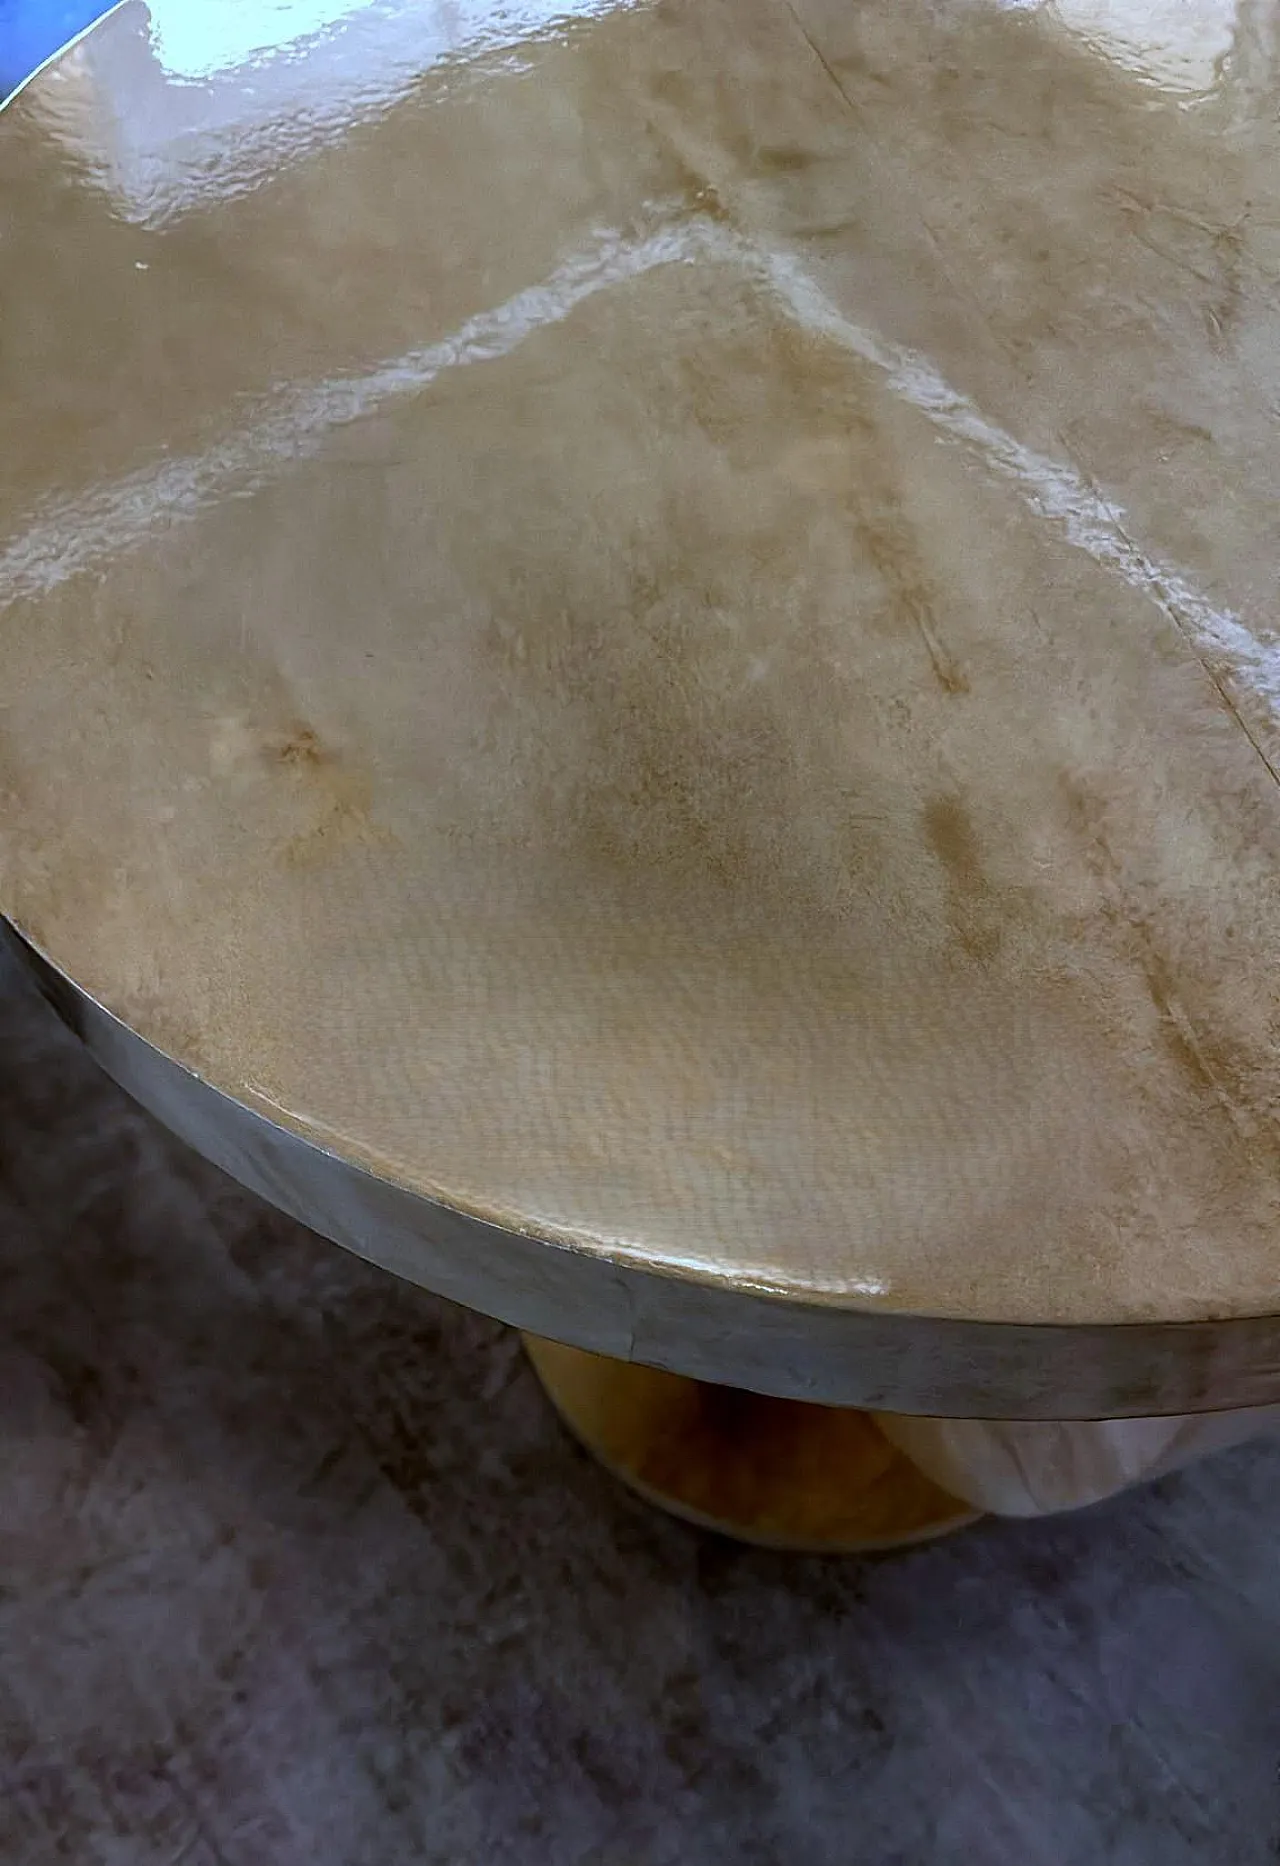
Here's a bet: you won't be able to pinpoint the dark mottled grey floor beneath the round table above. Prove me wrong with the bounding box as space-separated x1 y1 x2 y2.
0 947 1280 1866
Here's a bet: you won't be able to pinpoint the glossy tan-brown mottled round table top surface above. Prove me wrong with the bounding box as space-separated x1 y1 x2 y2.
0 0 1280 1396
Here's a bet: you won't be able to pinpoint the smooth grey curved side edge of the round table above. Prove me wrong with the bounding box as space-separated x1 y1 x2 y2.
10 918 1280 1420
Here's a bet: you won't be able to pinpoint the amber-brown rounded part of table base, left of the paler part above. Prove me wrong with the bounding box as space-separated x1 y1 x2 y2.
524 1334 978 1554
